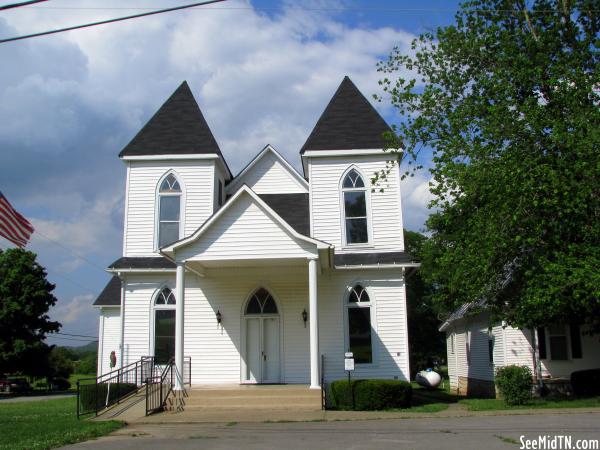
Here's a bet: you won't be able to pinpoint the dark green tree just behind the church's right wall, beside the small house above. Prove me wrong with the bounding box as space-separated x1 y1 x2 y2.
404 230 446 379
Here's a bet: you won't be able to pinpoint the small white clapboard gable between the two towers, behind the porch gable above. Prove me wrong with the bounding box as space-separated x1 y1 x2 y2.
229 151 307 194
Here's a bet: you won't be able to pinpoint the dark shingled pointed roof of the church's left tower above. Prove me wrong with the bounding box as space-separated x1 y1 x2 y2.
119 81 223 158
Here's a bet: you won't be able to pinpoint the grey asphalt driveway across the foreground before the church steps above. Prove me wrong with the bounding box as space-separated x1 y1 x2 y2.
64 410 600 450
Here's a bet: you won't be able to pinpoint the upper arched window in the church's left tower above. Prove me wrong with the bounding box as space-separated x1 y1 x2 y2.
158 174 181 248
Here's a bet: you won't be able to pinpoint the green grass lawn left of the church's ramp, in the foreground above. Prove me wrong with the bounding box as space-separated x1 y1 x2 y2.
0 398 124 450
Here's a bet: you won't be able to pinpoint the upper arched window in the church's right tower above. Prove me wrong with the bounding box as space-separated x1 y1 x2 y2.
342 169 369 245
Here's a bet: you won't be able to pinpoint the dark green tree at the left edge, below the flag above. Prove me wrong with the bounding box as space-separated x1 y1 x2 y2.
0 249 60 376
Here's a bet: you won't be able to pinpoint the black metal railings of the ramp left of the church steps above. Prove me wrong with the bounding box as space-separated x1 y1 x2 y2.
77 356 192 419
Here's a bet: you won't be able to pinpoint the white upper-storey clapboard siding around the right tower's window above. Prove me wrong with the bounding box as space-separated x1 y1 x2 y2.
308 155 404 253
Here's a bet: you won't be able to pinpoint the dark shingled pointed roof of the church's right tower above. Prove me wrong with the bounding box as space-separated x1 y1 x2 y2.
300 76 391 154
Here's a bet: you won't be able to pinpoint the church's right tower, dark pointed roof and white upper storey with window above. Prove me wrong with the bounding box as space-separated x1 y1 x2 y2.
300 77 404 253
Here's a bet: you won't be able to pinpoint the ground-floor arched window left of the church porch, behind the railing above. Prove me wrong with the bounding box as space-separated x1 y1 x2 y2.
154 288 176 364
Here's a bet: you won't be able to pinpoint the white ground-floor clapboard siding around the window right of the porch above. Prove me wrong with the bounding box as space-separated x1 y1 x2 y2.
318 270 410 381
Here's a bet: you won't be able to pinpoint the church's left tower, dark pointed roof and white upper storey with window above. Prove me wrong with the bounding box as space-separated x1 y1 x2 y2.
119 81 231 256
